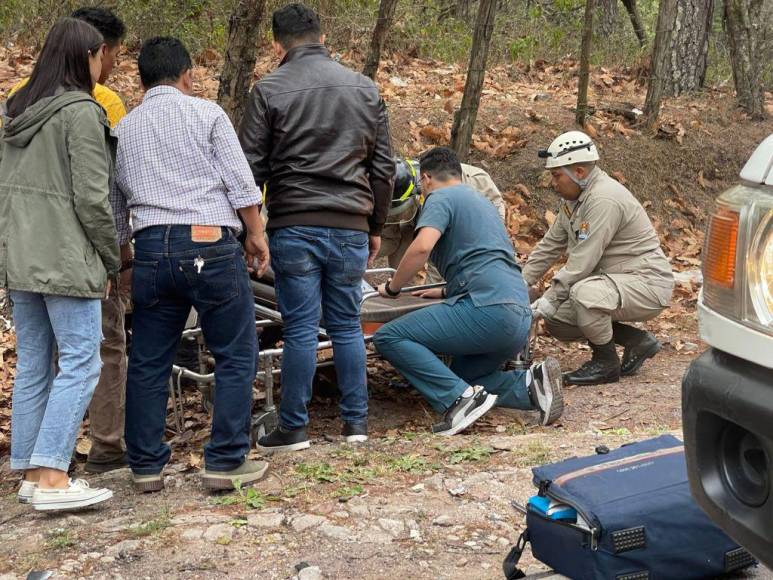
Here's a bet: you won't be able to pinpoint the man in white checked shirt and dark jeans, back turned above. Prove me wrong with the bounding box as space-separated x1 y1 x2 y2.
115 38 269 491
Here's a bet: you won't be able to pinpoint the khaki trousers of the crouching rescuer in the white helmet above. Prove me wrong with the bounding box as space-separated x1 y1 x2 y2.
545 274 673 344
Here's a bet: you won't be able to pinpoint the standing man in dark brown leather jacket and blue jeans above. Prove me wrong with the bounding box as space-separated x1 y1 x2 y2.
239 4 394 451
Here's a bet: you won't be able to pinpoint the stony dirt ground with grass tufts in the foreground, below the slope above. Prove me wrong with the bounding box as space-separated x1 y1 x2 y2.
0 316 764 580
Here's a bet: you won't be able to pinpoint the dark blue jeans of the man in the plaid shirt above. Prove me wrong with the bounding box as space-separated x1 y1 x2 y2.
126 226 257 475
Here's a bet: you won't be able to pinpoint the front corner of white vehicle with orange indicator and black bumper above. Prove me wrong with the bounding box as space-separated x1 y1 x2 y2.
682 135 773 566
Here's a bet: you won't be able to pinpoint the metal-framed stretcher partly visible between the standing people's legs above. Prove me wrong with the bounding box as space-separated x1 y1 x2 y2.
169 268 444 443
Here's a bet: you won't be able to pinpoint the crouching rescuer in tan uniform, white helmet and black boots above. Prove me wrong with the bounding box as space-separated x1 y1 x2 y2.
523 131 674 385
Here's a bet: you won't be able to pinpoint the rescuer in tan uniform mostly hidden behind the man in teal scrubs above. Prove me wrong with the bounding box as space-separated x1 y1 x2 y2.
378 159 505 284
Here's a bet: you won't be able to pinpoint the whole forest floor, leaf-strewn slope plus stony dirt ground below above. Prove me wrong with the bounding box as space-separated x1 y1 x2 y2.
0 47 773 579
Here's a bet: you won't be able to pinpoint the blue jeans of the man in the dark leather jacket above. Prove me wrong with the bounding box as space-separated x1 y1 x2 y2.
269 226 368 429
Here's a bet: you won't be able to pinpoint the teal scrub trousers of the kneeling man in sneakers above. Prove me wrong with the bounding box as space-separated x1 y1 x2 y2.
373 297 534 413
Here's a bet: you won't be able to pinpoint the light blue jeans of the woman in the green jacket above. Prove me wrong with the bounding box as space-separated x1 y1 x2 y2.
10 290 102 471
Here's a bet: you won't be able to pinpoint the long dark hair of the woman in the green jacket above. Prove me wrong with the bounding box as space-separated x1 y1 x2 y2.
8 18 103 118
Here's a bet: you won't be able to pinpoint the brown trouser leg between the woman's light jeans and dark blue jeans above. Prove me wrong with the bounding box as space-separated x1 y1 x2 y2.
89 290 127 463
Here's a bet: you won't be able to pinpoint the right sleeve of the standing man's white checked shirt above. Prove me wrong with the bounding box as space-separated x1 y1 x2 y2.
211 112 261 209
